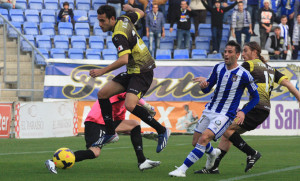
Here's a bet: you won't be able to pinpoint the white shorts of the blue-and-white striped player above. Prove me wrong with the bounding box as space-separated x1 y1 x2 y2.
195 109 232 140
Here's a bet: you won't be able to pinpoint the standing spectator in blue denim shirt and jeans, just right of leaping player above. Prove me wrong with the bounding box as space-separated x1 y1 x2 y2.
146 4 165 57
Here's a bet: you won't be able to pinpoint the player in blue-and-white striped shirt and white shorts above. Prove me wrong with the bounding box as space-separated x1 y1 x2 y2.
169 41 259 177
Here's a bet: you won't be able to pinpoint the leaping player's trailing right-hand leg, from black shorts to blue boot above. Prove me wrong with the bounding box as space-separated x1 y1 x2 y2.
125 71 171 153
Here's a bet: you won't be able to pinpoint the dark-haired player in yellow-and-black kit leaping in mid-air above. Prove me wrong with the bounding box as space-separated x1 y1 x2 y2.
90 4 171 153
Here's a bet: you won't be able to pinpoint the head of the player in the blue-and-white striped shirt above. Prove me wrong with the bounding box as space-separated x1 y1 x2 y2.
224 40 241 67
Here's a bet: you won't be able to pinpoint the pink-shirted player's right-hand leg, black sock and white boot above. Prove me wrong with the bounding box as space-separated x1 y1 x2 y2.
116 120 160 171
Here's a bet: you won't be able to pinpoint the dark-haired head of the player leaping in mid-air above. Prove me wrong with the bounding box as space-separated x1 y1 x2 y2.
97 5 116 32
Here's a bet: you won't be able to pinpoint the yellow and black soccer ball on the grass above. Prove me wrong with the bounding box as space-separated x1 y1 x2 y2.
53 148 75 169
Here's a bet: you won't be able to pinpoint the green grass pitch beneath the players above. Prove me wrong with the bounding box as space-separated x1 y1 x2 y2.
0 135 300 181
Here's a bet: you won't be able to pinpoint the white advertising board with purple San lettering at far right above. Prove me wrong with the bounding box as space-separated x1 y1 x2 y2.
241 101 300 136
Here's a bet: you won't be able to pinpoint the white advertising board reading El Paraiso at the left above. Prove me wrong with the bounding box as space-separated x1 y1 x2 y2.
15 101 78 138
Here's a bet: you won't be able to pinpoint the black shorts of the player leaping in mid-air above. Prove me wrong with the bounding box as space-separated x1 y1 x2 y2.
112 70 153 99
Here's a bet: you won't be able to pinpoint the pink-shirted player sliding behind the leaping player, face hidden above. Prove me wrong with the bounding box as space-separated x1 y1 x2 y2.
45 93 160 174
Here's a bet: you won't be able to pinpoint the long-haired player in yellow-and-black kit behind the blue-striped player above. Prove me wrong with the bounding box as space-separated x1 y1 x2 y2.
195 42 300 174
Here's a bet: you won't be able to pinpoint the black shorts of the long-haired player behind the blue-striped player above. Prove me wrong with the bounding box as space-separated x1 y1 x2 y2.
240 108 270 131
